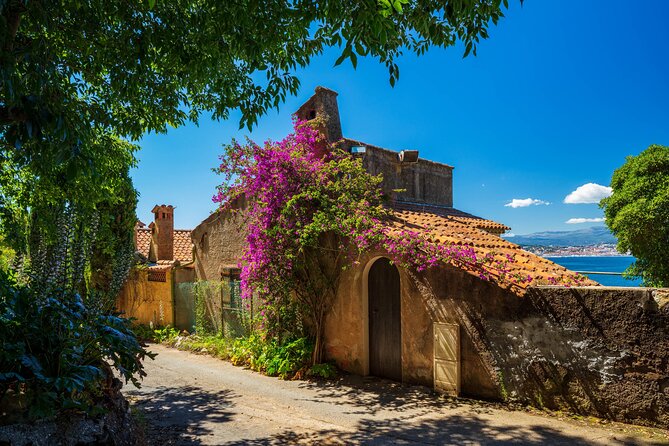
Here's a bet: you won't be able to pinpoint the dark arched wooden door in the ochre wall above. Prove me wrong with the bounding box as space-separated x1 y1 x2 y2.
367 258 402 381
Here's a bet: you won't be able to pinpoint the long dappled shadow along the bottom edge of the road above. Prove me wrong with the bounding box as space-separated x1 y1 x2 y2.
226 415 647 446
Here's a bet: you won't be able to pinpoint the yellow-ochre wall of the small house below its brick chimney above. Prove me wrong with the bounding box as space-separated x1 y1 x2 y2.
116 270 174 326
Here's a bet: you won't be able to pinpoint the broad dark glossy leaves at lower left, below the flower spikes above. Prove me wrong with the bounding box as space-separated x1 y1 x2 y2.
0 271 153 418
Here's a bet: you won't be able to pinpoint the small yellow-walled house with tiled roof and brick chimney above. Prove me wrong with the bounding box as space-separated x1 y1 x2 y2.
116 204 195 331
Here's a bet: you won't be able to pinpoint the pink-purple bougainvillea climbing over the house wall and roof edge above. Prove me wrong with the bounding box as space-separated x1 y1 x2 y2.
213 117 544 358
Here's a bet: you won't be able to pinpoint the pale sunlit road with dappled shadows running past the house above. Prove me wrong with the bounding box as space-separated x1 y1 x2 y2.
124 345 667 446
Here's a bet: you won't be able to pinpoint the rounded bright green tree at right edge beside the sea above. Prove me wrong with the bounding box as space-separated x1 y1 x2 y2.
600 145 669 287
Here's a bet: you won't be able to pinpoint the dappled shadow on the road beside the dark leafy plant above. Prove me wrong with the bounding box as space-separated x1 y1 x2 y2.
125 386 235 446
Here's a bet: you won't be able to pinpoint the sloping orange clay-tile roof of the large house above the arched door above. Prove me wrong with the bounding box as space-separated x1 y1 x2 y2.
393 209 598 294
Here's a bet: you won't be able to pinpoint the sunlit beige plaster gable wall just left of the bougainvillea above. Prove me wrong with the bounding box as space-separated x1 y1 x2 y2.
191 211 245 281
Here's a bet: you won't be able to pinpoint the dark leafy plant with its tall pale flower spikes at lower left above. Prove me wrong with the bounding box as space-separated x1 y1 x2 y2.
0 205 152 417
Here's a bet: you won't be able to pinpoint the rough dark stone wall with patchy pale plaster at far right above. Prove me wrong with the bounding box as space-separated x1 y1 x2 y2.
520 287 669 426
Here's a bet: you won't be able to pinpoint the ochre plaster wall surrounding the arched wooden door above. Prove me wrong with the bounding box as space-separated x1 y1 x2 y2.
325 252 500 398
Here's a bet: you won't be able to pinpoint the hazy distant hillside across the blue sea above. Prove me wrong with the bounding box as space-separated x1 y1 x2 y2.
500 226 617 246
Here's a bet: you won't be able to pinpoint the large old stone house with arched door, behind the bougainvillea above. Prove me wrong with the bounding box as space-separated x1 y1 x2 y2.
191 87 669 425
